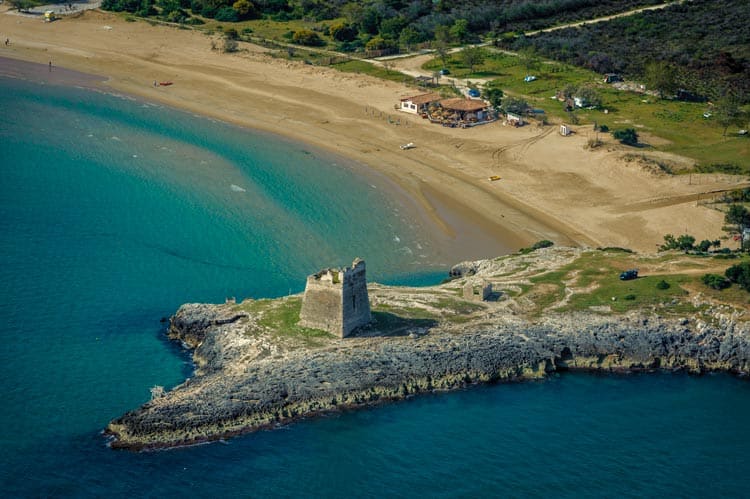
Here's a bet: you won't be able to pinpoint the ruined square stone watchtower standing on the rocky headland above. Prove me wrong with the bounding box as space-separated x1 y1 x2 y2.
299 258 372 338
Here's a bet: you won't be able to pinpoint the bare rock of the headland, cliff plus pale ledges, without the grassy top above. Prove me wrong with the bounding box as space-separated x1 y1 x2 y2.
107 250 750 450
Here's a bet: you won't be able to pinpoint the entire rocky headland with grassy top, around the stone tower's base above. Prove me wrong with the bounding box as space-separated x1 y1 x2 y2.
106 248 750 450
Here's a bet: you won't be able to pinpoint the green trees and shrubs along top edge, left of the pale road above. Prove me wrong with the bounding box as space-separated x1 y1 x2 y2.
101 0 661 50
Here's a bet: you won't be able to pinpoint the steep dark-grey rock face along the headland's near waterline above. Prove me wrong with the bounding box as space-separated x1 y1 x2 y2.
108 306 750 449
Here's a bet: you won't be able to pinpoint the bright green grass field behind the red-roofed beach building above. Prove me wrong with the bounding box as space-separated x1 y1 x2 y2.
423 49 750 174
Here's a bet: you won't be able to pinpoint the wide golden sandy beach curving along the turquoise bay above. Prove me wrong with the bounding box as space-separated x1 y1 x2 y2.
0 6 747 258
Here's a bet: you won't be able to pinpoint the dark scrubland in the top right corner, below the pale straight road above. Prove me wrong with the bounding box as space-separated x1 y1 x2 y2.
508 0 750 102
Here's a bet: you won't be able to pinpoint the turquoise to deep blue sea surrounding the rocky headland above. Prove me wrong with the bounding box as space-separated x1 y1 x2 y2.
0 65 750 497
